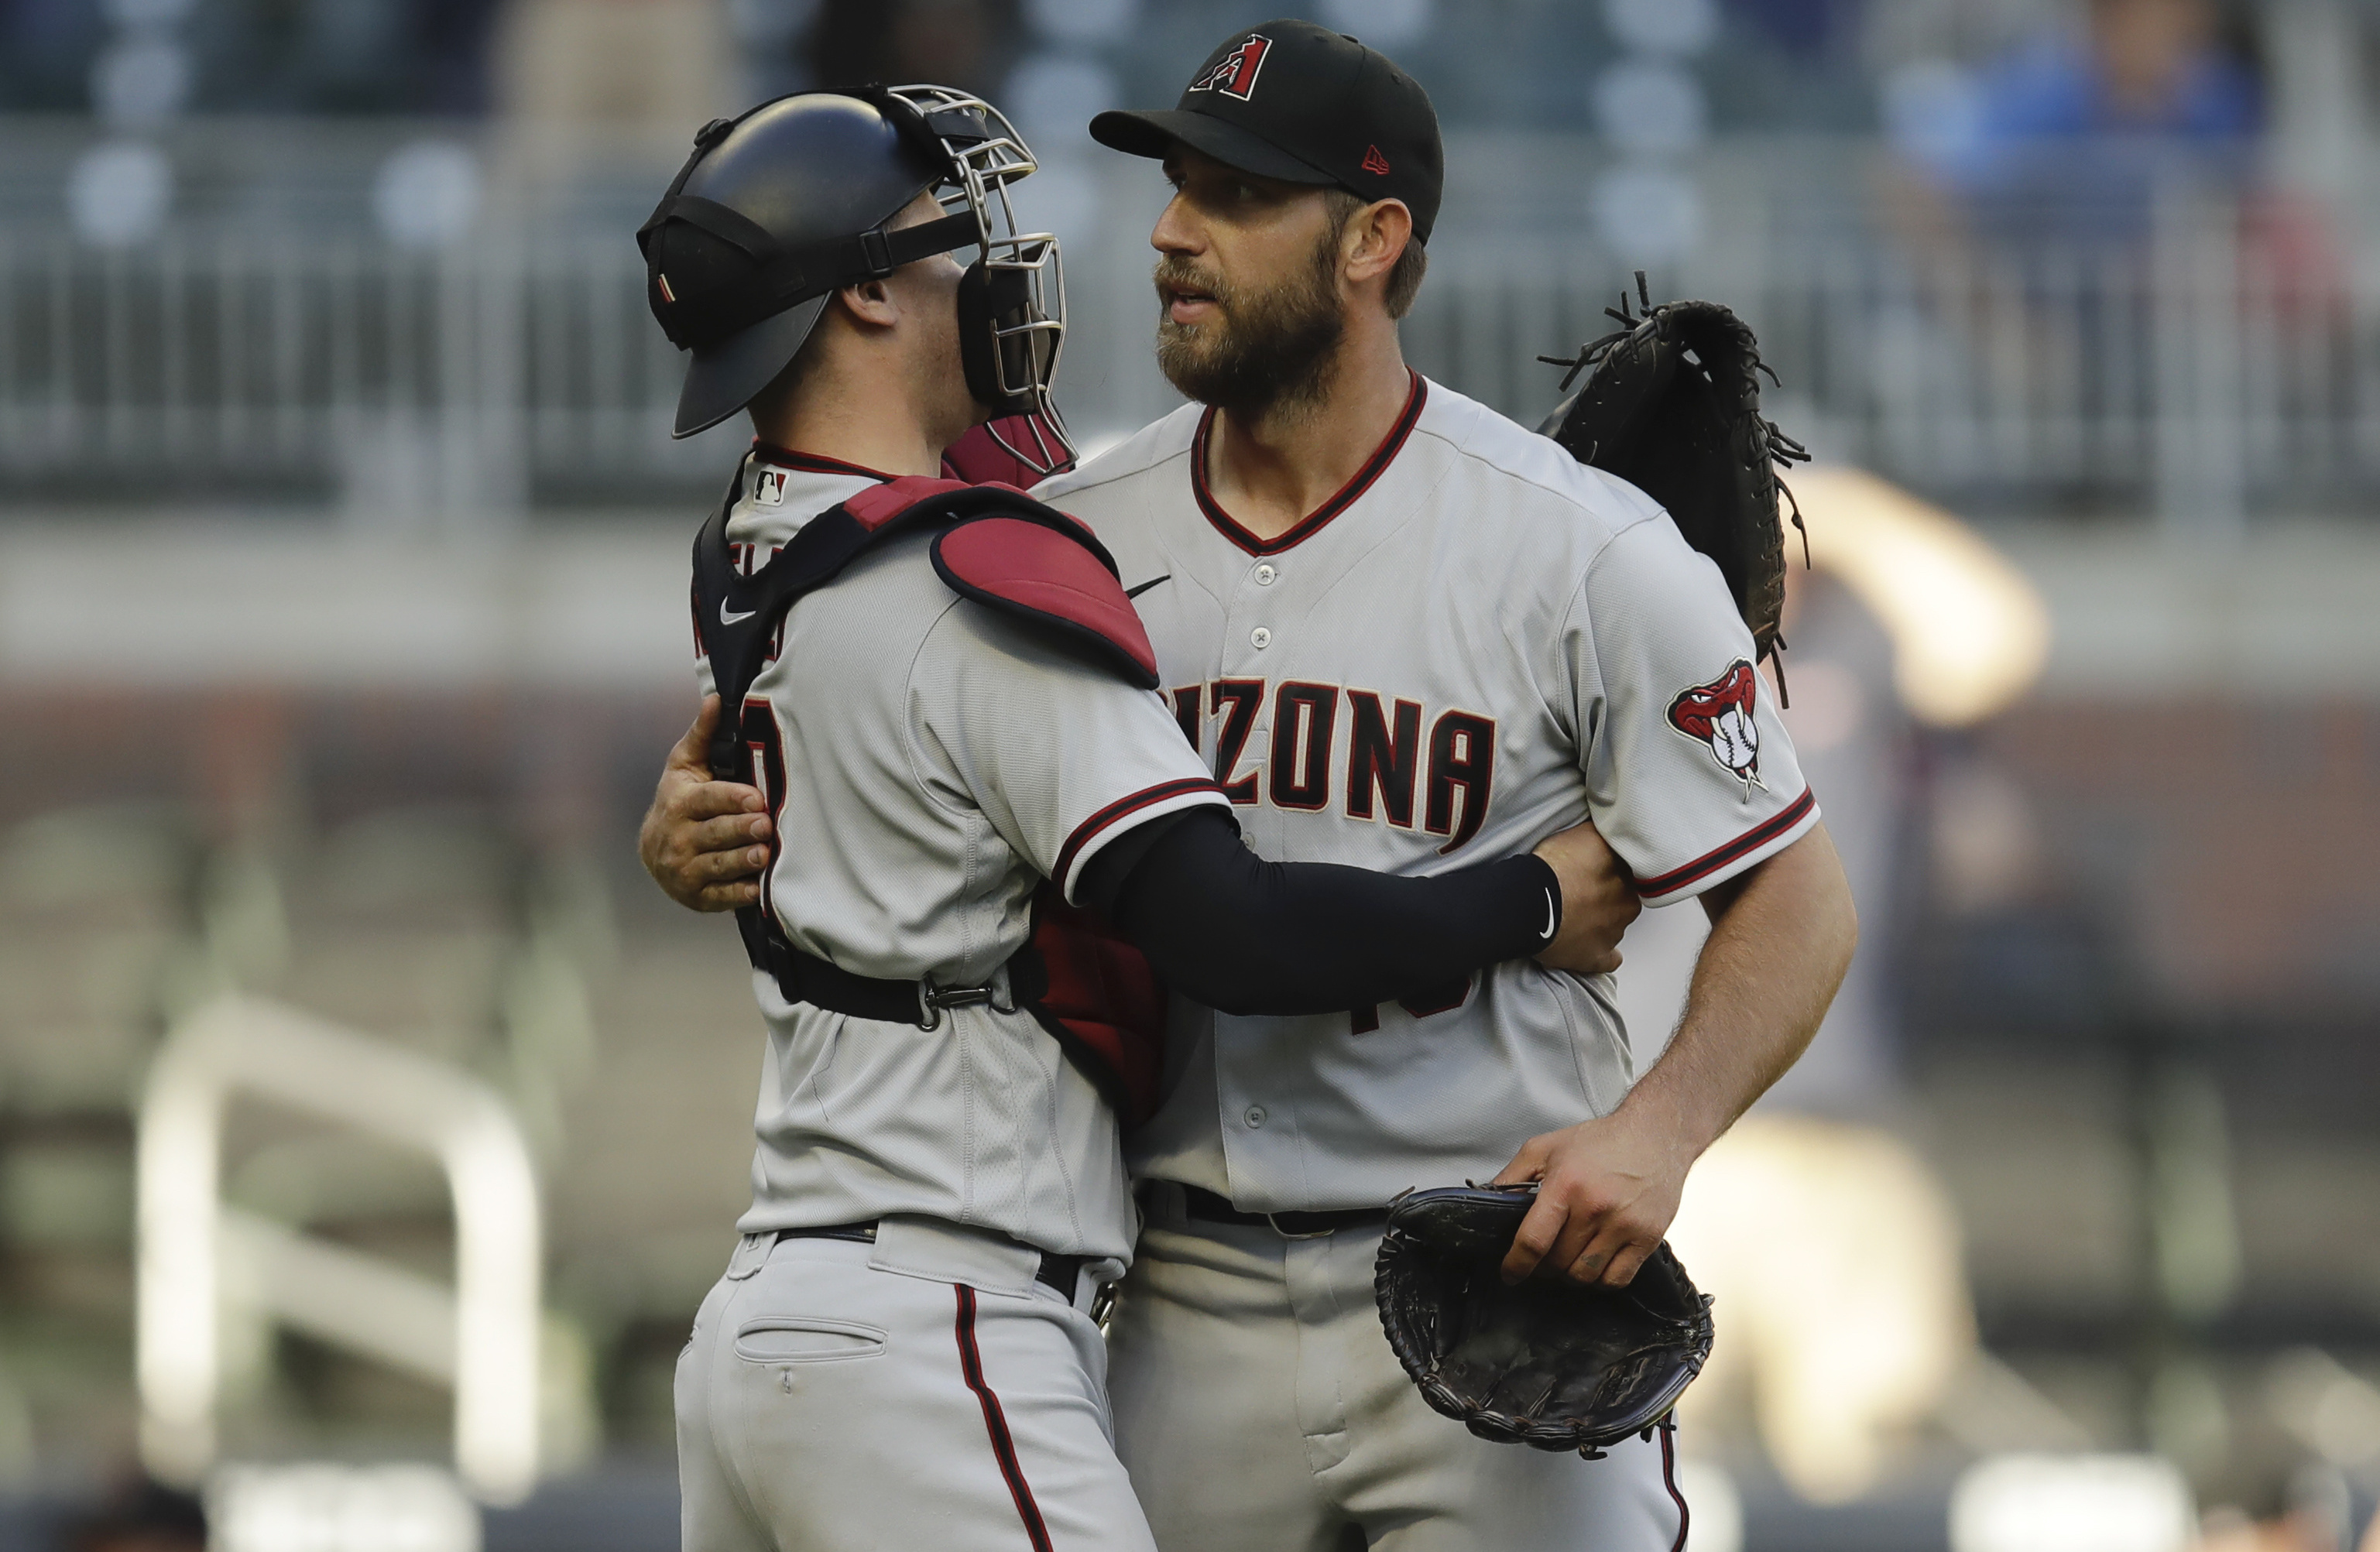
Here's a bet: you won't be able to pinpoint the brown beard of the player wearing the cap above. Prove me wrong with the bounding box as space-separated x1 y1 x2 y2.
1154 233 1347 419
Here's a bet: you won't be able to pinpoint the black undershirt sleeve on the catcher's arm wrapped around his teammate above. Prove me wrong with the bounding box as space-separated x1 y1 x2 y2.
1079 807 1562 1014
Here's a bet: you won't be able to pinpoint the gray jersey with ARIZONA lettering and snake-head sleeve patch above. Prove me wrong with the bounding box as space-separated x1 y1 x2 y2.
1037 374 1819 1211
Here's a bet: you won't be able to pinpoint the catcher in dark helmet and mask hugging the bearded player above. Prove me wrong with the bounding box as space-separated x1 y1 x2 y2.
638 88 1637 1552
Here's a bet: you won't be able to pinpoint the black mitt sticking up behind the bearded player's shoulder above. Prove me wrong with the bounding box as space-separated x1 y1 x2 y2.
1538 269 1809 693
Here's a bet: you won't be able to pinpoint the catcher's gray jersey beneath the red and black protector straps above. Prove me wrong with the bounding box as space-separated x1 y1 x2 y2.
700 454 1223 1262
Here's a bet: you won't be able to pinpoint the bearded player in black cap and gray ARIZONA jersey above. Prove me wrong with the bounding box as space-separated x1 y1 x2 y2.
645 19 1857 1552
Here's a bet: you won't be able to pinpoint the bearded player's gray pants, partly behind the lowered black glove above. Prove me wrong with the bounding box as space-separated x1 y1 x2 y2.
1109 1185 1678 1552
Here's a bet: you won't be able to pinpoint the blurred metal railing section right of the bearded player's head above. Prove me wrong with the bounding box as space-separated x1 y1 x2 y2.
1407 212 2380 529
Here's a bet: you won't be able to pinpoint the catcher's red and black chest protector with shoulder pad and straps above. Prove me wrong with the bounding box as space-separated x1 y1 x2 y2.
693 466 1166 1126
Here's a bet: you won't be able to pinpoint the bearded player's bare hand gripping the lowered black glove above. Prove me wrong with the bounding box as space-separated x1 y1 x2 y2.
1494 1105 1695 1288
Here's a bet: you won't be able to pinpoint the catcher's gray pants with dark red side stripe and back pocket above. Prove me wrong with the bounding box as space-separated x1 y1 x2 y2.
676 1218 1154 1552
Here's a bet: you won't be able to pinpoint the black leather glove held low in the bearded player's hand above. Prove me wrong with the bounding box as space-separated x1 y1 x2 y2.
1373 1185 1711 1459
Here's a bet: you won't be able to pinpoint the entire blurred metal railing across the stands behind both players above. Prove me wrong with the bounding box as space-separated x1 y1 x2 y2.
0 127 2380 531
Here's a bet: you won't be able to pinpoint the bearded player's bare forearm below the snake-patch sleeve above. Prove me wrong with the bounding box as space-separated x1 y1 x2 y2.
1620 826 1859 1157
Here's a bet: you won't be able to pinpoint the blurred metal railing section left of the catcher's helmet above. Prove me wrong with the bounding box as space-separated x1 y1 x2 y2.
0 231 716 512
